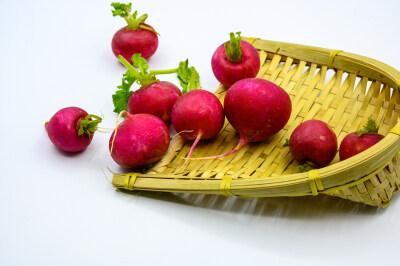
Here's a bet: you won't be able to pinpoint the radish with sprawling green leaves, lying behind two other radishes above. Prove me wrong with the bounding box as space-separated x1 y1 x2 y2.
112 54 195 123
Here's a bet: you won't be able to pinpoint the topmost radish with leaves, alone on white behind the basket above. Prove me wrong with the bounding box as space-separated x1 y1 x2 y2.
111 3 158 64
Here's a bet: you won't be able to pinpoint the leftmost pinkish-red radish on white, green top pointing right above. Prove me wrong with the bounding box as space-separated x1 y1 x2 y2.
45 107 102 152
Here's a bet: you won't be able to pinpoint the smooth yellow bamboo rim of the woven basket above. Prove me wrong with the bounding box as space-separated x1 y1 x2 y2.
113 37 400 197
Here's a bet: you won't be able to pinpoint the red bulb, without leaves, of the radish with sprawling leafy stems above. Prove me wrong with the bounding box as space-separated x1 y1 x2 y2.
128 81 182 122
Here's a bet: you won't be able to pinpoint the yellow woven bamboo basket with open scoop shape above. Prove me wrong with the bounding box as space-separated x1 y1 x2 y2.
112 38 400 207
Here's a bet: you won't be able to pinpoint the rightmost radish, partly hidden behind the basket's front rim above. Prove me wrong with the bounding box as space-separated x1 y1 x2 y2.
339 118 384 161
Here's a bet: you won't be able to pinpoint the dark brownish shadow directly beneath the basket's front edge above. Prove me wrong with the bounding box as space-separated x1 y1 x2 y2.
115 188 390 219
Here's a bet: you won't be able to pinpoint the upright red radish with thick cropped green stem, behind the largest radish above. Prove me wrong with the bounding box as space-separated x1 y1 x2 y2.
211 32 260 86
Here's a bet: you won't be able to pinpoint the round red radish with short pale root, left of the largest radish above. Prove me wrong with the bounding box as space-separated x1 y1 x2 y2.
171 90 225 164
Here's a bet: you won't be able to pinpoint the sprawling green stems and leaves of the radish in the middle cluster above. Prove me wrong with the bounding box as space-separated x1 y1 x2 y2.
112 54 201 113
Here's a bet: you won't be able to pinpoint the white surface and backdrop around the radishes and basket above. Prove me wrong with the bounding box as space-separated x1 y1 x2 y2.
0 0 400 265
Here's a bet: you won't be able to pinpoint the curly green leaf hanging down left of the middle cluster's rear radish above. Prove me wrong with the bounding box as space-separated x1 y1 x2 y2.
112 70 136 114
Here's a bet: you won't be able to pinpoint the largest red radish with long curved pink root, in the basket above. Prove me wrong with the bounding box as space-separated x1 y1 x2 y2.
184 78 292 160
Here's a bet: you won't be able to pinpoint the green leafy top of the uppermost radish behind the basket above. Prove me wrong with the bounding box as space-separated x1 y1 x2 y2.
111 2 158 34
